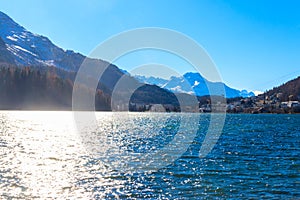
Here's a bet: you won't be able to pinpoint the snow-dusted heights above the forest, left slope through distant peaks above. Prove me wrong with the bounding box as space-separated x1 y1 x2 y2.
0 12 254 102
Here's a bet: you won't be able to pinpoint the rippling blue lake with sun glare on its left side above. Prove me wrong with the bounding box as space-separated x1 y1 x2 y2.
0 111 300 199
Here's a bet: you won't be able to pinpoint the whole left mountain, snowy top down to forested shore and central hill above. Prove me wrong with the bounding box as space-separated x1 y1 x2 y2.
0 12 178 110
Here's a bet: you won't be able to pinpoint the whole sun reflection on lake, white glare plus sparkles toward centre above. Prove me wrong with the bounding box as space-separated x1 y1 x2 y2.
0 111 185 198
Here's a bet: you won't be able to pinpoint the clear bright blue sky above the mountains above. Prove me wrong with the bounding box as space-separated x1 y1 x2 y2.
0 0 300 91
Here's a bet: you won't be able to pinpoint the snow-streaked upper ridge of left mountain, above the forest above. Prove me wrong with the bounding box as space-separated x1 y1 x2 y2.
0 12 129 89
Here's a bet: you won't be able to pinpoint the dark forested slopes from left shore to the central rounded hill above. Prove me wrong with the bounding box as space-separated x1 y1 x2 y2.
0 64 178 111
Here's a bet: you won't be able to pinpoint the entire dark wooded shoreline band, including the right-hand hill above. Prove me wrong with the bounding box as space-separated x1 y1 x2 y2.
0 63 300 113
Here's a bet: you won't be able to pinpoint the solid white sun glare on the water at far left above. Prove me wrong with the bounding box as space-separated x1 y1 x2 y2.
0 111 102 198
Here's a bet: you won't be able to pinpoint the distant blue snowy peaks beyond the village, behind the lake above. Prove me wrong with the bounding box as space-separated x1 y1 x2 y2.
134 72 255 98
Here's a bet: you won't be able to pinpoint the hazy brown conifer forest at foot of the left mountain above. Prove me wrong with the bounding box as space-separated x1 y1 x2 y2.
0 66 110 110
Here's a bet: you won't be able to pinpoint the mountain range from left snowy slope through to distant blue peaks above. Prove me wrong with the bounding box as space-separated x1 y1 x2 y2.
0 12 282 110
